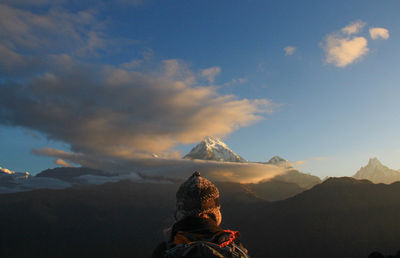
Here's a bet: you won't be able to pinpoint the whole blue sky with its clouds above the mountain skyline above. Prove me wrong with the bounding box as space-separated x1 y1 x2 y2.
0 0 400 178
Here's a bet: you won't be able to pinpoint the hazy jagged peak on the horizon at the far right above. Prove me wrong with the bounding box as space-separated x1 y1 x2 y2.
353 158 400 184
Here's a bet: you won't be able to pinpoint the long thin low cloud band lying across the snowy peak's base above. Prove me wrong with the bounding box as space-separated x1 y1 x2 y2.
32 148 288 183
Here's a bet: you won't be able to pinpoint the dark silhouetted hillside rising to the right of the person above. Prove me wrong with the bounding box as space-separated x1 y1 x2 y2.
240 178 400 257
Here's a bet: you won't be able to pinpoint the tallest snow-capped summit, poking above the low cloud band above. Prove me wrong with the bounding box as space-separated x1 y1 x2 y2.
183 136 247 162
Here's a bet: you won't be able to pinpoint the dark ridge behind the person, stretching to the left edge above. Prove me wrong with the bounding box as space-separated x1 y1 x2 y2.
0 180 266 258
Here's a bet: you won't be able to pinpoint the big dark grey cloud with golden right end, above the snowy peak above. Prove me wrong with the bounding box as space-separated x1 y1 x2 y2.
0 61 272 157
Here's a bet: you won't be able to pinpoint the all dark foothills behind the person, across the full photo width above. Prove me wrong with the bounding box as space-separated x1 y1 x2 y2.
0 178 400 258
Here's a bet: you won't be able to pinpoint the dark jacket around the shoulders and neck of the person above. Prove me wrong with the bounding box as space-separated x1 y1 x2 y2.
152 217 247 258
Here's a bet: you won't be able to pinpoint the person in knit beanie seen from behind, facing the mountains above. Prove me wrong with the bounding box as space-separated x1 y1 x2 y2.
152 171 249 258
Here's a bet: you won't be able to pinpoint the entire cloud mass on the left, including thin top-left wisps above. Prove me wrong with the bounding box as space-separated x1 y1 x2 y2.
0 2 273 164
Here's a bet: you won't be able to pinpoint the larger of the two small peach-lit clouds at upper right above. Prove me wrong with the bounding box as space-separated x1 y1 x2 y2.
321 22 369 67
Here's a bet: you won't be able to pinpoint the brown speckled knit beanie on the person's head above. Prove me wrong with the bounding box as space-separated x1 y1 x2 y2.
175 171 222 225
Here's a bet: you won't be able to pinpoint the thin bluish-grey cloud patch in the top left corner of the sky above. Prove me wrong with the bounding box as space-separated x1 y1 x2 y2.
0 4 106 55
